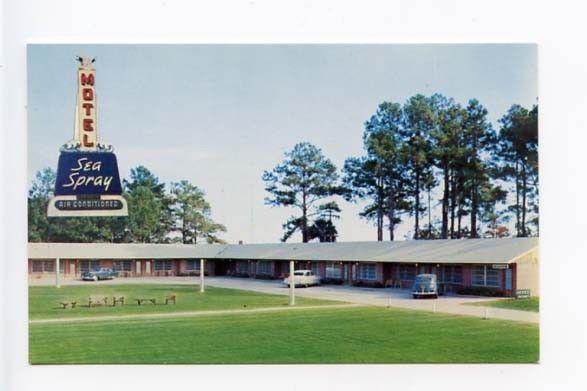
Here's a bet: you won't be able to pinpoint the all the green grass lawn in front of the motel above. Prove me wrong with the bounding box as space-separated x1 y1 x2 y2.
29 285 539 364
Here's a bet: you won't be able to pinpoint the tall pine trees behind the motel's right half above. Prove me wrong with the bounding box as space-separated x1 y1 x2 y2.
262 94 539 242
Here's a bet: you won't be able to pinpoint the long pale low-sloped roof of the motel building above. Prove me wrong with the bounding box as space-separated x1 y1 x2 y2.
29 238 538 263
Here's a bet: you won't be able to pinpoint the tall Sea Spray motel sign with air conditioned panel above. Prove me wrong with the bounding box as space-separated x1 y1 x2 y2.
47 57 128 217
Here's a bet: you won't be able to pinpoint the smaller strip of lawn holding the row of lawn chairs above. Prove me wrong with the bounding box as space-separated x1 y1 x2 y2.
29 282 340 320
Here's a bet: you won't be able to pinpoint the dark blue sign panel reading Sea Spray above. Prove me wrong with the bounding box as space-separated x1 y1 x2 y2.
55 152 122 196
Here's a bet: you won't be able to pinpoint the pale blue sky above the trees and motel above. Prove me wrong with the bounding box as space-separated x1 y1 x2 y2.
27 44 538 243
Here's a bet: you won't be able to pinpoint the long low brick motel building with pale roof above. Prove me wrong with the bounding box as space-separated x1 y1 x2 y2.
28 238 539 296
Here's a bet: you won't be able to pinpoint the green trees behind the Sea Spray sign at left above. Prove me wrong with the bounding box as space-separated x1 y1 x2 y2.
28 166 226 244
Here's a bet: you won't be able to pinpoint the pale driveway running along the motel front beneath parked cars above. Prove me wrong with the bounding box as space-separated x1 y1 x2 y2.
29 277 540 323
